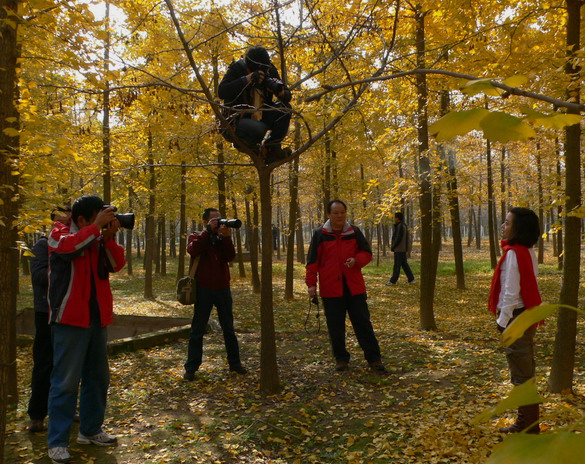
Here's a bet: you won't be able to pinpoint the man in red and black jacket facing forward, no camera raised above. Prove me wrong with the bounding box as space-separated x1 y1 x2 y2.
305 200 386 372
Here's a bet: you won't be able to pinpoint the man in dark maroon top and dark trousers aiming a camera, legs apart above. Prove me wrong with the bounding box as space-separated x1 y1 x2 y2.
183 208 247 381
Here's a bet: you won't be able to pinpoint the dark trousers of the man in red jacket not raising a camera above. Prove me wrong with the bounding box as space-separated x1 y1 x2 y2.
323 293 381 363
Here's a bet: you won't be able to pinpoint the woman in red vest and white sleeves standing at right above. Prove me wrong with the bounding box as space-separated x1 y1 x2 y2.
489 208 542 433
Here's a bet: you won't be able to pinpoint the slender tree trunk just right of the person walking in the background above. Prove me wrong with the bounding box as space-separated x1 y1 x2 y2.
415 5 437 330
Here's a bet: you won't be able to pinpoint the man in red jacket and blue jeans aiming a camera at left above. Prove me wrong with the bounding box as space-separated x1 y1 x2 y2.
48 195 126 463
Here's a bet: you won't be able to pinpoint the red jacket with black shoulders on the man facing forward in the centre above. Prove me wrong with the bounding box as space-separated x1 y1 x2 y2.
305 221 372 298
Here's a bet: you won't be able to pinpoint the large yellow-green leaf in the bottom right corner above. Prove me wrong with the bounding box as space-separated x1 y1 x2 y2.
486 432 585 464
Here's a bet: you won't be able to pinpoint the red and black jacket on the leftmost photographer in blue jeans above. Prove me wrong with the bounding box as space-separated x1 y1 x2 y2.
49 222 126 327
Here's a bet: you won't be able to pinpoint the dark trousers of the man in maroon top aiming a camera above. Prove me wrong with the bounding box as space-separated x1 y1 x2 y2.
185 287 241 372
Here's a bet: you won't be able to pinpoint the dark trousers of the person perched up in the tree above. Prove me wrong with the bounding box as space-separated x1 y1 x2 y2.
229 102 291 148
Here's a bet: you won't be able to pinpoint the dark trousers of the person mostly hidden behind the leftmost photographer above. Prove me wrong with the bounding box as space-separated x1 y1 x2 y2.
28 312 53 420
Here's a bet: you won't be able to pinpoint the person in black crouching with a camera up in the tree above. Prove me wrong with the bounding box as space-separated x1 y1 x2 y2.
218 47 292 164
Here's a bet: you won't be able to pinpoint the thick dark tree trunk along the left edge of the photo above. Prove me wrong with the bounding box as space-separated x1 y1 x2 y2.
0 0 21 456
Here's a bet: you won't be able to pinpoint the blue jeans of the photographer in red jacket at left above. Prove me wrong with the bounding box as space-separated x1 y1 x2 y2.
48 324 110 448
